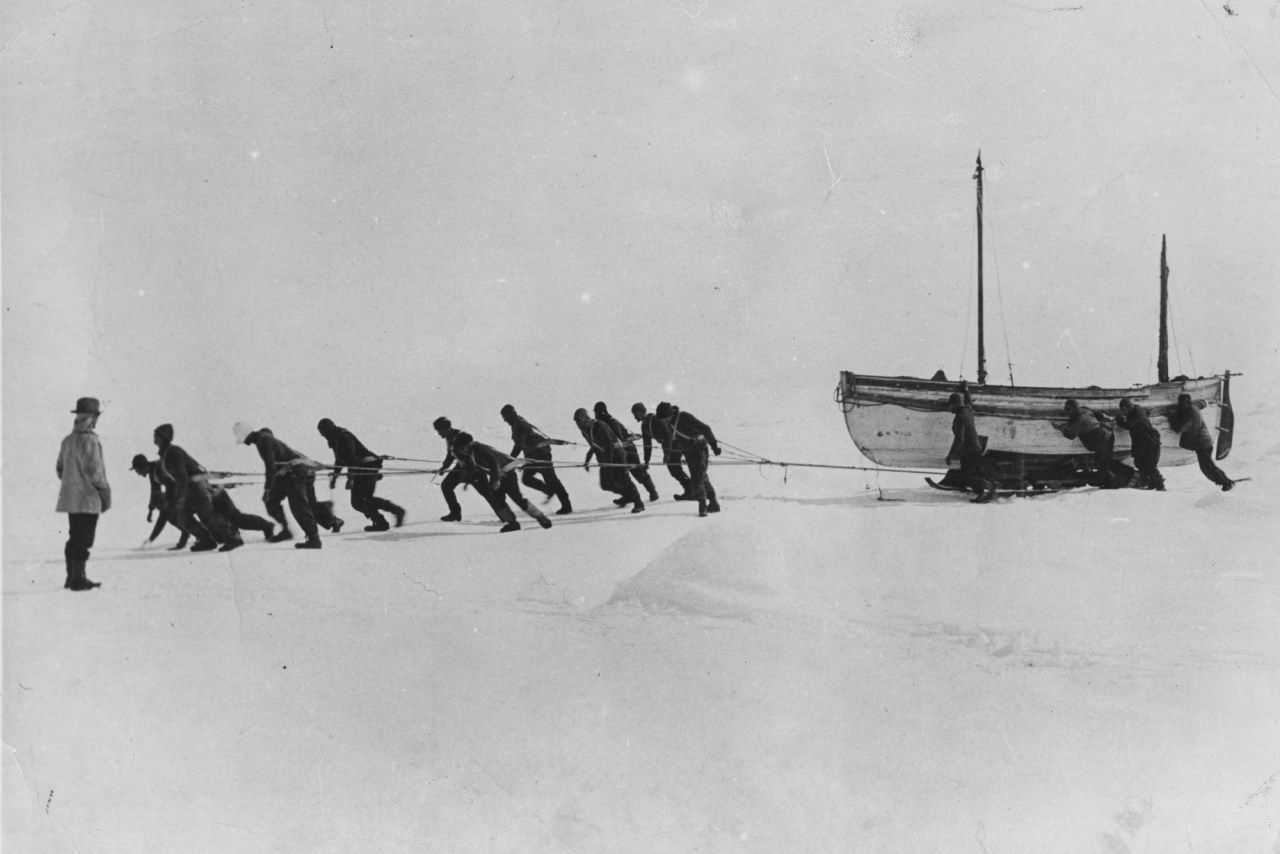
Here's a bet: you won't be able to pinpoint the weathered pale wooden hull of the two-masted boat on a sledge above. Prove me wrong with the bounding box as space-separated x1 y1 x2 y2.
836 371 1225 469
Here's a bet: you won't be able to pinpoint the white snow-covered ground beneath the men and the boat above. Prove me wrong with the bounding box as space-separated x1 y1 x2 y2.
4 406 1280 853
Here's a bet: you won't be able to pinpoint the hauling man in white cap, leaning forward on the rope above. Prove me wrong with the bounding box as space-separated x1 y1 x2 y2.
232 423 343 548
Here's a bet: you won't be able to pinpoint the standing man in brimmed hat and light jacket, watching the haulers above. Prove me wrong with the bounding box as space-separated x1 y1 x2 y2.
58 397 111 590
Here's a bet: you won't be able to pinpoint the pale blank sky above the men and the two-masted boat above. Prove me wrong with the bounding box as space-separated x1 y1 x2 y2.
0 0 1280 489
